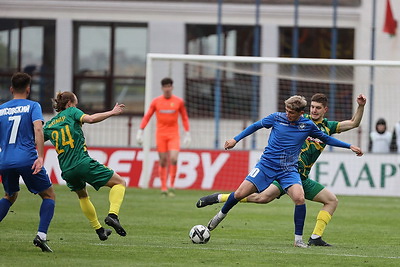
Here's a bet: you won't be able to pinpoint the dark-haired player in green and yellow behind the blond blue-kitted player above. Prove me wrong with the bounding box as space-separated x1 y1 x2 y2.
196 94 367 246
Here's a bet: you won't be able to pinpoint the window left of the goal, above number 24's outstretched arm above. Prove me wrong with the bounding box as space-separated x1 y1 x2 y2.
74 22 147 114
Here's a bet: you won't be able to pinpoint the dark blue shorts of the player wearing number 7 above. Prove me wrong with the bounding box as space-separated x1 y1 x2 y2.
0 166 51 196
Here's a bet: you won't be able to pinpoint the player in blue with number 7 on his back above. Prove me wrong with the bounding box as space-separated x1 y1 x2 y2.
0 72 55 252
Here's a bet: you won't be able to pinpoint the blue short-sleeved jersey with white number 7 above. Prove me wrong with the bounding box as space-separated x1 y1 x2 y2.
0 99 43 170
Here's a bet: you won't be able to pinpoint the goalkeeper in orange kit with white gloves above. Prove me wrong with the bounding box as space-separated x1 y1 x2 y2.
136 78 191 196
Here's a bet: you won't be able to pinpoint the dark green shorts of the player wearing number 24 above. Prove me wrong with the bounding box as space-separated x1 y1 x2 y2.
61 158 114 191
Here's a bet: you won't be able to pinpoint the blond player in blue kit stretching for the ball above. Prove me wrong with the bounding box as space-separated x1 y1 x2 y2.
207 96 363 248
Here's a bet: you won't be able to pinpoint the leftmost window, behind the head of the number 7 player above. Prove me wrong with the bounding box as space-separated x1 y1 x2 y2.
0 19 55 112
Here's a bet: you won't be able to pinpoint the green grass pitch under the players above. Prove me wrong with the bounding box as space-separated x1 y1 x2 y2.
0 185 400 267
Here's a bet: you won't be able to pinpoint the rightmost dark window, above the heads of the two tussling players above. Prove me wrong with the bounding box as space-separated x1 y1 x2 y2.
278 27 354 121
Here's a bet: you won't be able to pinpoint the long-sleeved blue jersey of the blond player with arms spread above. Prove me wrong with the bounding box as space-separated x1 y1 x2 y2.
234 112 350 171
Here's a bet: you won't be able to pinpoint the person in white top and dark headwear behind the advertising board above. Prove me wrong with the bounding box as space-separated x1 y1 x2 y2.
369 118 392 153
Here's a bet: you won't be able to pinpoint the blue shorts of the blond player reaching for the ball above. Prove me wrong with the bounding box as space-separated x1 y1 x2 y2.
246 162 302 192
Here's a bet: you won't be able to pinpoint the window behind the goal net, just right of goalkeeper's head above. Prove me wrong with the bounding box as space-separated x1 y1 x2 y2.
185 24 261 119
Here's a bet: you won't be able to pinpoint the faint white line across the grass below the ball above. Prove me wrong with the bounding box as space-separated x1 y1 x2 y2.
92 243 400 259
